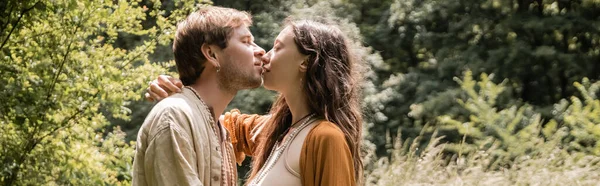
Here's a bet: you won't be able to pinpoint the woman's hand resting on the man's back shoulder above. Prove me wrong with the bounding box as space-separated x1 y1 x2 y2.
145 75 183 101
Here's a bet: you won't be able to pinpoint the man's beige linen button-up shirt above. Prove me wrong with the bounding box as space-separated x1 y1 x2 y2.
133 88 237 186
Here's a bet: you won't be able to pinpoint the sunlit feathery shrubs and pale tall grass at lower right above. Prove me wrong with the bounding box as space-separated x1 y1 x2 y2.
366 71 600 185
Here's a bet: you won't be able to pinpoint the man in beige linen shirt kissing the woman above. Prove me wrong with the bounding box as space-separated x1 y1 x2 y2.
133 6 265 186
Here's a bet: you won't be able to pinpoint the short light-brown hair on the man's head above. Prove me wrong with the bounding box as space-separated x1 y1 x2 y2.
173 6 252 86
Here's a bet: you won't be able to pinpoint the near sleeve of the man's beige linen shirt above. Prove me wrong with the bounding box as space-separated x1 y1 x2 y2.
144 114 202 185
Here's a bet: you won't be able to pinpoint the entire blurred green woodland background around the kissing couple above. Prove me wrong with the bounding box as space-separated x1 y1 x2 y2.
0 0 600 185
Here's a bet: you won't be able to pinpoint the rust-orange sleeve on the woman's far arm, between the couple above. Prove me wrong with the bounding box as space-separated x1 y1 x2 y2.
223 109 270 164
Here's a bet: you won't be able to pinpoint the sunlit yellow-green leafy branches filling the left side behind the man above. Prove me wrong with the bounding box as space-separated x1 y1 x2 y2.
0 0 206 185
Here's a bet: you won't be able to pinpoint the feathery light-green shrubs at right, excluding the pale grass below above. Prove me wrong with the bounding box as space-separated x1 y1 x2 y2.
438 71 600 167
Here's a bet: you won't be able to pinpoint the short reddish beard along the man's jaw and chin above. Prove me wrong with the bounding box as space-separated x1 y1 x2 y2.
217 63 263 93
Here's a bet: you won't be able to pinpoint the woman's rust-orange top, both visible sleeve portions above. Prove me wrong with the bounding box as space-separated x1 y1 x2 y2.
223 109 358 186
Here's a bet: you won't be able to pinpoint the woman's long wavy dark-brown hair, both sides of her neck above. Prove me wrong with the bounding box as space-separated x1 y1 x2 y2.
251 19 363 184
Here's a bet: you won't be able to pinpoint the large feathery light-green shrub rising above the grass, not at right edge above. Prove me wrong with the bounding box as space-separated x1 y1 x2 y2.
438 71 544 164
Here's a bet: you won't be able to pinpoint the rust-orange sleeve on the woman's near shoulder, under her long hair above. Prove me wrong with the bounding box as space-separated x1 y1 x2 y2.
300 122 356 186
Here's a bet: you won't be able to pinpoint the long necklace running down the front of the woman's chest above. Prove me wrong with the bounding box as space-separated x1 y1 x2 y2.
248 113 315 186
